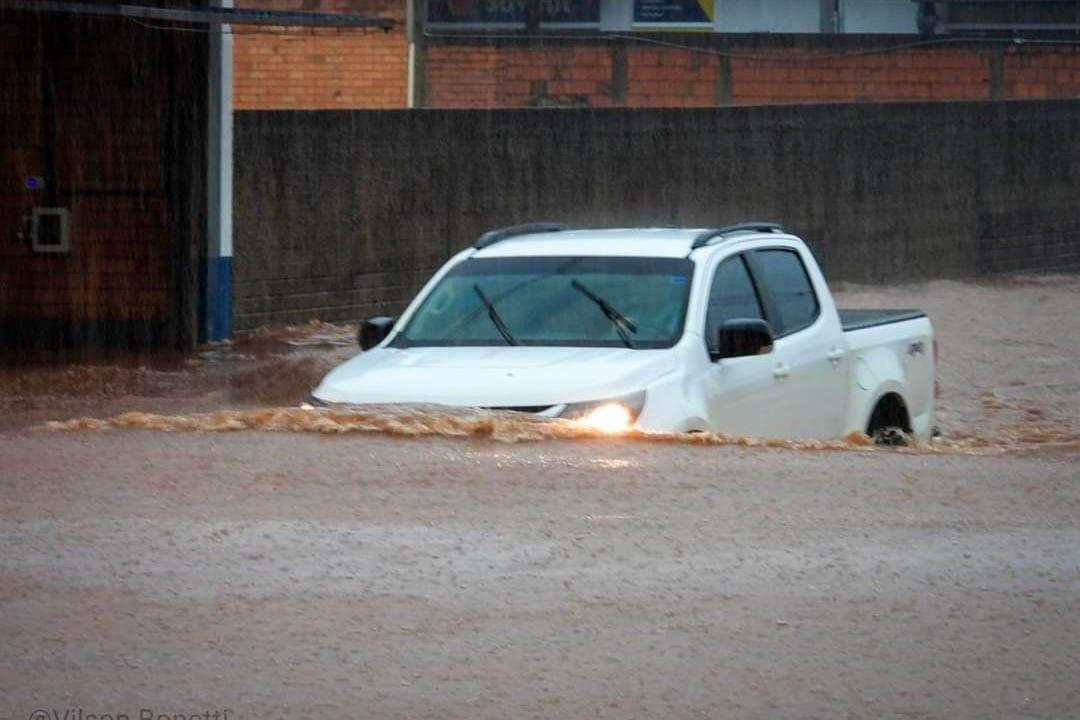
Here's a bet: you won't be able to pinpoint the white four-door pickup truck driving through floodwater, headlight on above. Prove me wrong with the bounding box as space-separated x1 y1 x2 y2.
311 222 934 441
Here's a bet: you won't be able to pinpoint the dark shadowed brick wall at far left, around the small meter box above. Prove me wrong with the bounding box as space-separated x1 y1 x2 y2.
0 13 170 321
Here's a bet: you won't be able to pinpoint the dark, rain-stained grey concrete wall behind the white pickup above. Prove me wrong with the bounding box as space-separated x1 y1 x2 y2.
235 100 1080 329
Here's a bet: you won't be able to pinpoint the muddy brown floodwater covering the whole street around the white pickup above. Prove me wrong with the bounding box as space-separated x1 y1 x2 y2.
0 276 1080 719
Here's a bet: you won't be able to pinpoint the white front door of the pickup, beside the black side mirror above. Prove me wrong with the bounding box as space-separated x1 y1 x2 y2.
703 255 784 437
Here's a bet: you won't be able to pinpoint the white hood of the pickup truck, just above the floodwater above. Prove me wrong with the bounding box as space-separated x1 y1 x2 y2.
313 345 675 407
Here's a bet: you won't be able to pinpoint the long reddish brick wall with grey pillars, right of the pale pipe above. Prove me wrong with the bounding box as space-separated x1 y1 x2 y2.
426 35 1080 108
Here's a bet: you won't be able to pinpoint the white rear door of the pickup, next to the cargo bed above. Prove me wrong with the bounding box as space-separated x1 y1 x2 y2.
746 247 849 438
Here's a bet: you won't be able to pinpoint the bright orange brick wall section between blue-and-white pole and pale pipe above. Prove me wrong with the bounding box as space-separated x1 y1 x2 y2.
233 0 408 110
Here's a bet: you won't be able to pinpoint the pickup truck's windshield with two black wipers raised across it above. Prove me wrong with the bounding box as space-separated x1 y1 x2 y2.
391 257 693 350
